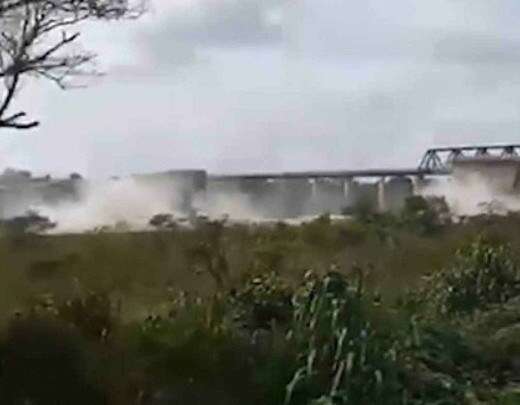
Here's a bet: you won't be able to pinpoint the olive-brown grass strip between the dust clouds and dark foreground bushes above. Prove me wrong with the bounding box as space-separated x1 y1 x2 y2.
0 208 520 310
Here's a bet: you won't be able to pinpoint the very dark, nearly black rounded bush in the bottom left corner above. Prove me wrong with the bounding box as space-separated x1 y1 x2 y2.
0 316 106 405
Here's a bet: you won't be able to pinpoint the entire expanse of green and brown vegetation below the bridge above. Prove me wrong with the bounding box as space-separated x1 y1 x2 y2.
0 199 520 405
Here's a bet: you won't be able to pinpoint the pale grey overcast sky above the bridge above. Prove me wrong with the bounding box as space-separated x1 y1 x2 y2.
0 0 520 177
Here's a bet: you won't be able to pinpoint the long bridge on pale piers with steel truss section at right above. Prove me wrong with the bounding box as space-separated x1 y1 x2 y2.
202 144 520 216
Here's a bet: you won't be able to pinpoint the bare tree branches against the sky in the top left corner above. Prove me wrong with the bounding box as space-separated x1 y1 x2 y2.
0 0 145 129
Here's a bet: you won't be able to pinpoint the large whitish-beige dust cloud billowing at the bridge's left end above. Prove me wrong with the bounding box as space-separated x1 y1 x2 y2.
35 177 263 230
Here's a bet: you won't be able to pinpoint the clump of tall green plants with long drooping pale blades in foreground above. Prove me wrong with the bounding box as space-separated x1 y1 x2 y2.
285 272 404 405
